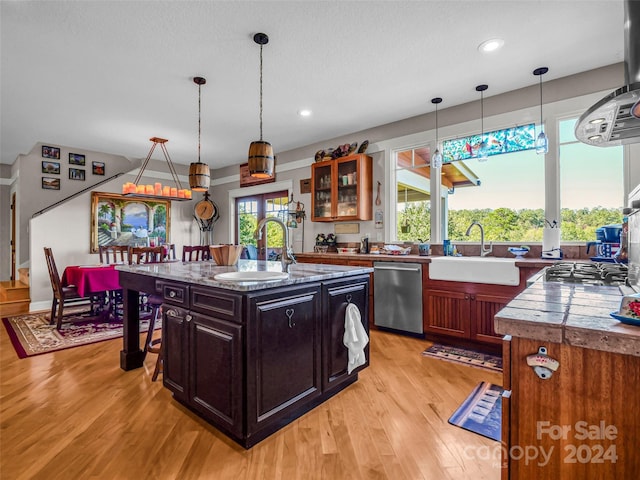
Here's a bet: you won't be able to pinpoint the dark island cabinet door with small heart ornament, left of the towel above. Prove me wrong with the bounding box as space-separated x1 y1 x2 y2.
247 285 321 435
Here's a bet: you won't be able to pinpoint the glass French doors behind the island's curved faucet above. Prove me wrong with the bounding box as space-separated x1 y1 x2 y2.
235 190 289 260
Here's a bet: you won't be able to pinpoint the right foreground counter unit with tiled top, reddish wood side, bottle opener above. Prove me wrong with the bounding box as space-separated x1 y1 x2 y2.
495 277 640 480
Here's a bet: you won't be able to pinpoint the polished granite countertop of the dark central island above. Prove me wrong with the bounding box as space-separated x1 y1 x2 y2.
116 260 373 292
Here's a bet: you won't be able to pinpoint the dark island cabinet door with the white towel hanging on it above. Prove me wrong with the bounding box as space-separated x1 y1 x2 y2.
322 277 369 391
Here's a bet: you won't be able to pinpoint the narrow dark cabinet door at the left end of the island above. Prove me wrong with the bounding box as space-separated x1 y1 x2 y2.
162 303 189 402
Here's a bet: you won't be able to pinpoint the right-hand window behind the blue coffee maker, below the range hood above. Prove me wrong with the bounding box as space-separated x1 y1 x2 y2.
559 118 625 241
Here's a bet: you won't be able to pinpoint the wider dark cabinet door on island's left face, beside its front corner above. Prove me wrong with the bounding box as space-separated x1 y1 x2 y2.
189 312 243 437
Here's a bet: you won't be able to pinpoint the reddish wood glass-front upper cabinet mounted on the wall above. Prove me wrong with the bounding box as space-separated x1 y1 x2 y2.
311 154 373 222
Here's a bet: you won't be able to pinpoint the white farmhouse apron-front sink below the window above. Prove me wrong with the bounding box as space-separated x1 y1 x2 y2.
429 257 520 286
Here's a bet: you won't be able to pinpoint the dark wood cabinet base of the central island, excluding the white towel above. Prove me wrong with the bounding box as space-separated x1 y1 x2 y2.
159 274 369 448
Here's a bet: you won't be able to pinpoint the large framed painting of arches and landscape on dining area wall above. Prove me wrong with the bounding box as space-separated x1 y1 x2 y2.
91 192 171 253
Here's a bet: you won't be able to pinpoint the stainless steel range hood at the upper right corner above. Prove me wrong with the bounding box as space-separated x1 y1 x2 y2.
575 0 640 147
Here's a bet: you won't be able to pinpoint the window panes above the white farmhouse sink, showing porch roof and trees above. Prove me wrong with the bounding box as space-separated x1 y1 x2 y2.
395 146 545 242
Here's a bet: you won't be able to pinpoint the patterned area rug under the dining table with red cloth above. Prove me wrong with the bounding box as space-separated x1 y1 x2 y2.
2 312 160 358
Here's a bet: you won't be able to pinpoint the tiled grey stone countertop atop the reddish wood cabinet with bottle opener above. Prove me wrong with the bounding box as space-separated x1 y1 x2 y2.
494 277 640 356
